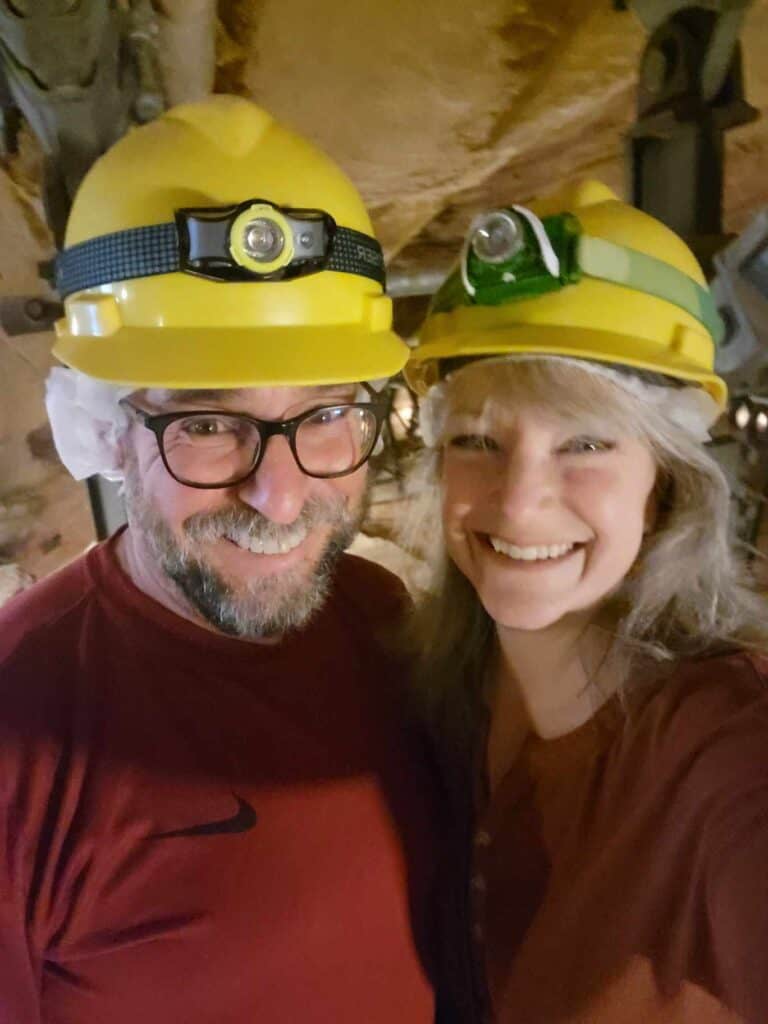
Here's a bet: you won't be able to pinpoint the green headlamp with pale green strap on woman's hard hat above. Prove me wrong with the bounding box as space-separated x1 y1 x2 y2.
431 206 724 344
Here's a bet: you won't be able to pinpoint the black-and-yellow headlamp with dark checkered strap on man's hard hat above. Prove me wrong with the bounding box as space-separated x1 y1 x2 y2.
56 199 385 298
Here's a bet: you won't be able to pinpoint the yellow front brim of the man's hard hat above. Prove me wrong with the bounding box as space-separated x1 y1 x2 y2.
53 326 409 388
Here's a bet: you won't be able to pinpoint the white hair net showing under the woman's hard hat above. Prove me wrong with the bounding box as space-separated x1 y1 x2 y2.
419 354 722 447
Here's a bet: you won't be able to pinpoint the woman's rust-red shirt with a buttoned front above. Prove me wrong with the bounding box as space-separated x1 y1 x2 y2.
462 654 768 1024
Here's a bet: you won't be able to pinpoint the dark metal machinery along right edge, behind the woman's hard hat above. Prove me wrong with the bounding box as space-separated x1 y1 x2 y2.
616 0 768 546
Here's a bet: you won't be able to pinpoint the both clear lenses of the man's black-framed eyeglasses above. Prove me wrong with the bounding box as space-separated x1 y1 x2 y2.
163 406 377 486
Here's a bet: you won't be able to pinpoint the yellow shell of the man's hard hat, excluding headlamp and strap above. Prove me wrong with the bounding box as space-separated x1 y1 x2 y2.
53 96 408 388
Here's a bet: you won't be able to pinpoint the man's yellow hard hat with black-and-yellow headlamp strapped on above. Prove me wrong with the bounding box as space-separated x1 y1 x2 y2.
53 96 408 388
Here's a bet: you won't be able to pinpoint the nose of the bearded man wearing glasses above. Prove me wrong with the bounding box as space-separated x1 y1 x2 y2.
237 436 312 525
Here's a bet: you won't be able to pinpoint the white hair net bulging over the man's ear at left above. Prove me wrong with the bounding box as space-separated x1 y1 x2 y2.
45 367 136 480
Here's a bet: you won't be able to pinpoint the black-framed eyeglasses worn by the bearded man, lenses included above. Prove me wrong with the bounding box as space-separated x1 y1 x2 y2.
122 400 386 489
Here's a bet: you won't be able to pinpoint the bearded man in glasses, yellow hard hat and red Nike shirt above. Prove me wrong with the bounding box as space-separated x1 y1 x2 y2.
0 97 433 1024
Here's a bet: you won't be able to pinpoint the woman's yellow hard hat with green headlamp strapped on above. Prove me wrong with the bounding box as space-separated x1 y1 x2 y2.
406 181 727 407
